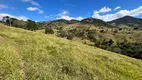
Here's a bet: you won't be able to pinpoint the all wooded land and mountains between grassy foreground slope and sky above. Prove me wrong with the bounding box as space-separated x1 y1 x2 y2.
3 16 142 59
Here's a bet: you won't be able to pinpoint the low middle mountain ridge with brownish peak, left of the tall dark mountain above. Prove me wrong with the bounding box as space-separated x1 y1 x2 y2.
37 18 111 28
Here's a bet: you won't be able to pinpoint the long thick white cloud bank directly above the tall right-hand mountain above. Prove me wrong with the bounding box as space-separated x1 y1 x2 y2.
92 6 142 21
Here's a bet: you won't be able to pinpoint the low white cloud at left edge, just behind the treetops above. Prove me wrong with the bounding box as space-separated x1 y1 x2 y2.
0 13 29 21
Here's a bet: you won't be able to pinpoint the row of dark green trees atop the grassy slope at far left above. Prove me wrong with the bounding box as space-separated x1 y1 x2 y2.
2 16 38 31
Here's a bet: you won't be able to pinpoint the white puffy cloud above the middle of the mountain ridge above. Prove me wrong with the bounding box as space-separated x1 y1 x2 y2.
56 10 84 20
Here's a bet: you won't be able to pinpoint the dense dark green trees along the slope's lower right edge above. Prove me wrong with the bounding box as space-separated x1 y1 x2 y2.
95 39 142 59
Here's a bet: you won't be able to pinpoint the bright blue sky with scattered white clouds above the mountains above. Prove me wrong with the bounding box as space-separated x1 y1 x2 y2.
0 0 142 21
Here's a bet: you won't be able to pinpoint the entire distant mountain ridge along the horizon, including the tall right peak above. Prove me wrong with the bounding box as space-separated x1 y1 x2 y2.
38 16 142 27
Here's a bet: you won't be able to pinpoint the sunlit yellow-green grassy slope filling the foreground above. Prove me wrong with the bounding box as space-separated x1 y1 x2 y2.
0 24 142 80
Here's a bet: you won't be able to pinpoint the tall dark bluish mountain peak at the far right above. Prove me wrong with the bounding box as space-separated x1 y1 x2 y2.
108 16 142 27
